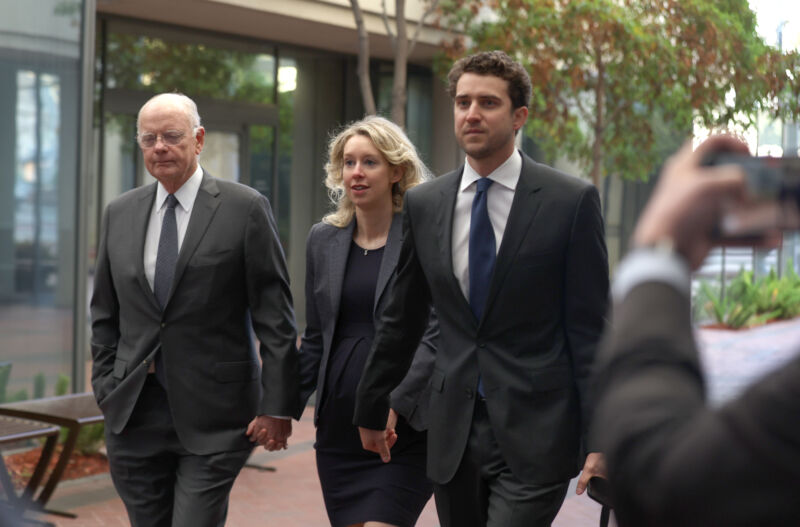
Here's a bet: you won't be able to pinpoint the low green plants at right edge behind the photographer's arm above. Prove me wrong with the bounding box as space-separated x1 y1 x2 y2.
697 265 800 329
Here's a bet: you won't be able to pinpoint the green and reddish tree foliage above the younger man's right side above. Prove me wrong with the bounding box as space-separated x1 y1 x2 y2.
442 0 800 184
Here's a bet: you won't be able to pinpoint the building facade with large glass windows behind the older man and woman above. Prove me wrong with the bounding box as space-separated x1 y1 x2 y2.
0 0 460 400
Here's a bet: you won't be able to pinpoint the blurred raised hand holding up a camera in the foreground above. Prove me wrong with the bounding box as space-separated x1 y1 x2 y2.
633 135 748 270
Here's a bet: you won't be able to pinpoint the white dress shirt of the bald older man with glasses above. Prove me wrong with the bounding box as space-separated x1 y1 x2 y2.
144 164 203 289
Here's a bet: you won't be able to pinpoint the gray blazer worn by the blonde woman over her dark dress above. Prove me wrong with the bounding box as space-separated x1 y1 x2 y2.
300 214 439 430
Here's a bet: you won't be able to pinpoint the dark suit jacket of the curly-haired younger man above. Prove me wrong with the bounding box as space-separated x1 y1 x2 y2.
355 154 608 483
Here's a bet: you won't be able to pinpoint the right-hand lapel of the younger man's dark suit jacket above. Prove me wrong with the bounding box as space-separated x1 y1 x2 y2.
484 154 542 313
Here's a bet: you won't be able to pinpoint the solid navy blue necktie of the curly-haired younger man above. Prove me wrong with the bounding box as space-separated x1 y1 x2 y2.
469 177 497 397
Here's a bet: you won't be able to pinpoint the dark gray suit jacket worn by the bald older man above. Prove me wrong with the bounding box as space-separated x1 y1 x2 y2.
91 173 301 455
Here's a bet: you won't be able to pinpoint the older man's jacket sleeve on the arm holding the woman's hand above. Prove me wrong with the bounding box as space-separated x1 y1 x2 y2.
245 196 302 419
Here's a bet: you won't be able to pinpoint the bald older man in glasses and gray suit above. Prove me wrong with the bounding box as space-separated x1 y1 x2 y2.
91 94 301 527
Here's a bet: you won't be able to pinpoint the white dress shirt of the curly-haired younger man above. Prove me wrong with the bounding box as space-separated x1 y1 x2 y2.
451 150 522 299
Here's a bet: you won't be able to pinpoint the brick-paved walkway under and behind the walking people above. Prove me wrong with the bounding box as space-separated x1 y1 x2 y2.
23 319 800 527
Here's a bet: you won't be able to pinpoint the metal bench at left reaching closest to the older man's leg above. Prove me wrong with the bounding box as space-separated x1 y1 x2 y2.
0 393 103 517
